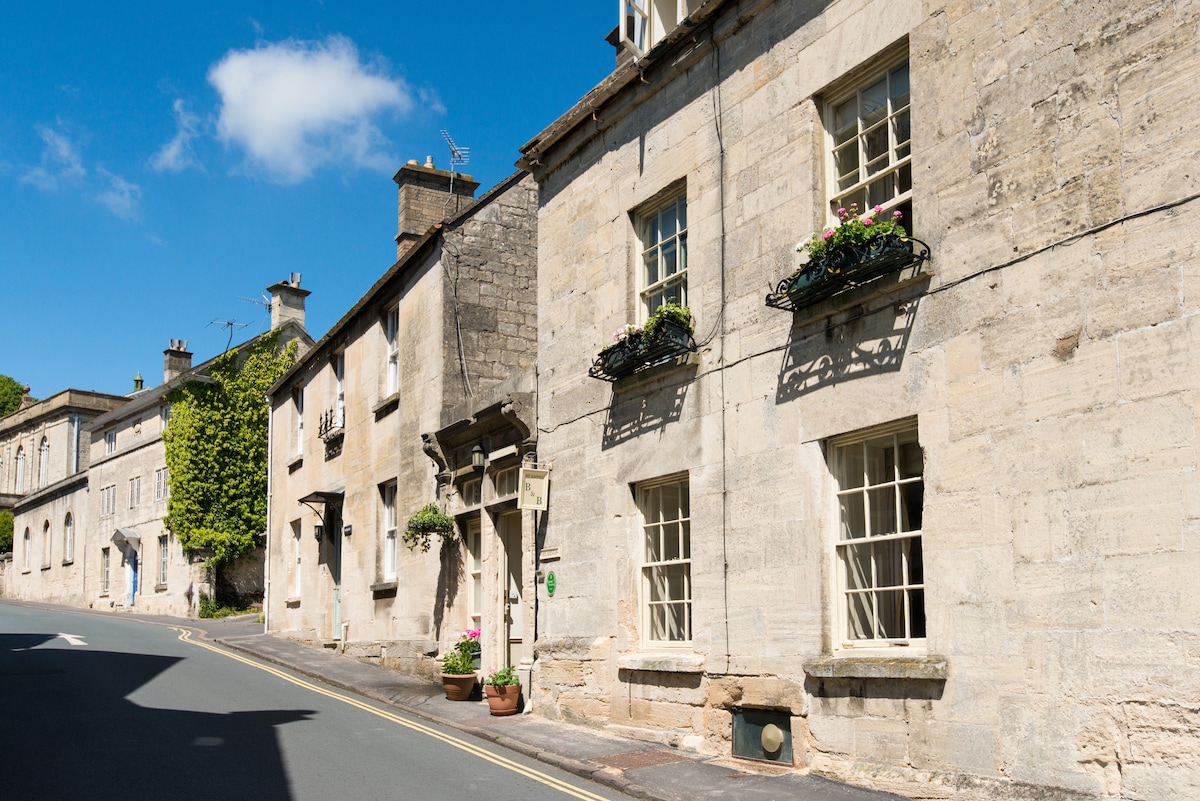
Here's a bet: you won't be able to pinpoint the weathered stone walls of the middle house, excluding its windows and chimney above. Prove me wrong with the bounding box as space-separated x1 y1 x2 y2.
268 177 536 675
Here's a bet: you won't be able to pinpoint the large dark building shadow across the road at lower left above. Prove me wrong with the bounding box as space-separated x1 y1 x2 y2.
0 634 313 801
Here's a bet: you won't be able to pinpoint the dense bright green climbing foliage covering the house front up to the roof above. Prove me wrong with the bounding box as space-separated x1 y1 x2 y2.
163 335 295 566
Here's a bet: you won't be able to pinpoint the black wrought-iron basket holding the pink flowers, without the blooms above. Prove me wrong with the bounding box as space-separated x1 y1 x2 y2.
767 235 929 312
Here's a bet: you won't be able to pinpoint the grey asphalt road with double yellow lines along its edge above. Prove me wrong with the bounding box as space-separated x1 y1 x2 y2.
0 604 626 801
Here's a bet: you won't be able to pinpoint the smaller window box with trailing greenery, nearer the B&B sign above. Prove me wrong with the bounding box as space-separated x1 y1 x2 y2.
588 303 696 381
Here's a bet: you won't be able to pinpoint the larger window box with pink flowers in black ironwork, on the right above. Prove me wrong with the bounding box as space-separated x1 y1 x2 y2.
767 203 929 312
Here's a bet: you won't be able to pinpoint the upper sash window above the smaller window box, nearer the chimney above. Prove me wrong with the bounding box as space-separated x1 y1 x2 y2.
636 189 688 321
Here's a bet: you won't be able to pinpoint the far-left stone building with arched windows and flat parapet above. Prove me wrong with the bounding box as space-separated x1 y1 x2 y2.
0 390 126 603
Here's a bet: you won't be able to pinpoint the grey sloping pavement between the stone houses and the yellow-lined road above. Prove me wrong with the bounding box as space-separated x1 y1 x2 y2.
60 604 905 801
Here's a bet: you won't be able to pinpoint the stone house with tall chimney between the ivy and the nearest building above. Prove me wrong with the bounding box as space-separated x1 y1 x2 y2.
266 161 536 674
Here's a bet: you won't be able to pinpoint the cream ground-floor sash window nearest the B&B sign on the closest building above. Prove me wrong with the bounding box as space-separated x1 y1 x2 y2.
637 475 694 649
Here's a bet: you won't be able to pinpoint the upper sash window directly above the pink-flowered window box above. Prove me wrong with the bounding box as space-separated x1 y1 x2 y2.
824 56 912 225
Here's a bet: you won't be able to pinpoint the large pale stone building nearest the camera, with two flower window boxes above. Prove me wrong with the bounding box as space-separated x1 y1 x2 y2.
521 0 1200 799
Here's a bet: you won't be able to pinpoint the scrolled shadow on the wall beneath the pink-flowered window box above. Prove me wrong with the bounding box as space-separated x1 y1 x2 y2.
775 299 917 403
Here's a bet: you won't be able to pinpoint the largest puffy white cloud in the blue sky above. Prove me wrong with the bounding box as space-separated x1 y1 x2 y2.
209 36 414 183
